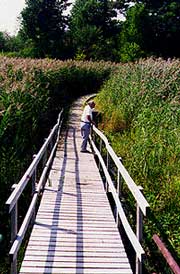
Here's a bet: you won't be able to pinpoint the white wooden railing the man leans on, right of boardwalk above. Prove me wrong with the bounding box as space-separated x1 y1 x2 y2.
90 126 149 274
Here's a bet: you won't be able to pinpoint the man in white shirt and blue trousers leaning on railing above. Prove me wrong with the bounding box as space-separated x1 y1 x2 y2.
81 101 95 152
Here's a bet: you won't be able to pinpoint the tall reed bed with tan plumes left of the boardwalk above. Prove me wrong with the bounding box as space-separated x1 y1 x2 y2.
0 57 114 273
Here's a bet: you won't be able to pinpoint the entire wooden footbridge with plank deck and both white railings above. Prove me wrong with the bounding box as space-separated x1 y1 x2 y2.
6 97 179 274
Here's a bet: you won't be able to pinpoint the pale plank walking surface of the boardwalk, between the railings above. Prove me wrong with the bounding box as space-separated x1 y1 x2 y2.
20 98 132 274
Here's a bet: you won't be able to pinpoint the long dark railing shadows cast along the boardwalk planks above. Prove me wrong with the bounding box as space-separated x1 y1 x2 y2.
36 127 84 274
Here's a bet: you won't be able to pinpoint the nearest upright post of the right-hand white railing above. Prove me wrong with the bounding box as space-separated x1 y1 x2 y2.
136 186 143 274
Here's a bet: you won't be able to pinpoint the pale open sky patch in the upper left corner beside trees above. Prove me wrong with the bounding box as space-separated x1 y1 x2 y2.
0 0 25 35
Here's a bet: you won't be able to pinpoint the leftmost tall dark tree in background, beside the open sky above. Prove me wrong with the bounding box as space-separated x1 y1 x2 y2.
20 0 68 58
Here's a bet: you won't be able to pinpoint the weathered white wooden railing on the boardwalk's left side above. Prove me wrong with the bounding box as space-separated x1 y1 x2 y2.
6 110 63 274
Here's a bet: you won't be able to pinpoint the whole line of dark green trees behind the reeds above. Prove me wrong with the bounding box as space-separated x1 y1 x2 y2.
0 0 180 62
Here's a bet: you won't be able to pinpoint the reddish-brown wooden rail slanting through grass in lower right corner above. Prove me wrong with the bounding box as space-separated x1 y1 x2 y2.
153 234 180 274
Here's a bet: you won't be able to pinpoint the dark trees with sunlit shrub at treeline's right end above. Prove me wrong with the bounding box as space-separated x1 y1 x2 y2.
116 0 180 58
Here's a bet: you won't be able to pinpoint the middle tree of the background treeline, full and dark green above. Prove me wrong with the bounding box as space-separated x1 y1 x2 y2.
70 0 119 60
